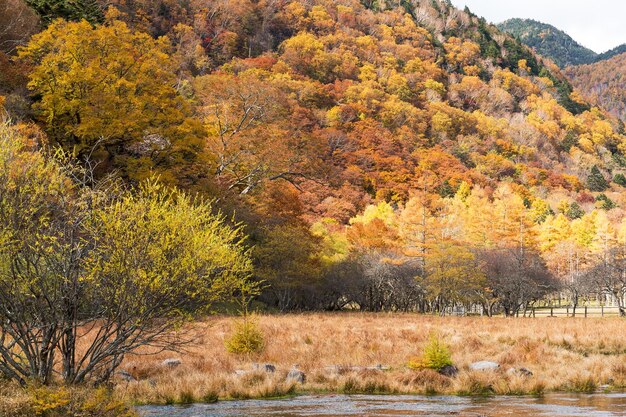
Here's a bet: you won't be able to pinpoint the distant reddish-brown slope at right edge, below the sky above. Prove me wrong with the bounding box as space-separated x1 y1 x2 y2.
565 53 626 120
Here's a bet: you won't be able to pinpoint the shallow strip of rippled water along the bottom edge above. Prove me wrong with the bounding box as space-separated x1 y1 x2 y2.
139 393 626 417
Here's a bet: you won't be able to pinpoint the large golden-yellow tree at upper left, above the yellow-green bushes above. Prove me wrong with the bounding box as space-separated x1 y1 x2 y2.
19 14 203 181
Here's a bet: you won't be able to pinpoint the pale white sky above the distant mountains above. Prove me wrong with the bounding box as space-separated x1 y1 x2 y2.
452 0 626 52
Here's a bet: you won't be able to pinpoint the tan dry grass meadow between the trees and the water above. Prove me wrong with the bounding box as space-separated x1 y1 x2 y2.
116 314 626 403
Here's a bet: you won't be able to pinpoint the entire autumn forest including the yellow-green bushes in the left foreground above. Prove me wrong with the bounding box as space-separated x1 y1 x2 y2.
0 0 626 410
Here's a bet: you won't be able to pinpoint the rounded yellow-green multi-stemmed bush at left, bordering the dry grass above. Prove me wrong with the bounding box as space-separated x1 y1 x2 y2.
77 181 256 383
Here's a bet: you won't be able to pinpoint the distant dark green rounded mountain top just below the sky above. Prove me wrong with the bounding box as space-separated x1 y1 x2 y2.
498 19 598 68
